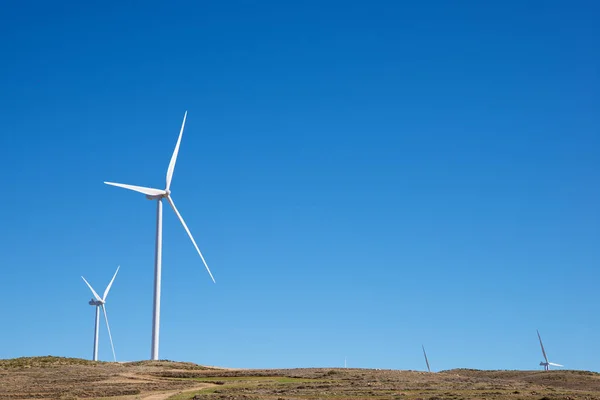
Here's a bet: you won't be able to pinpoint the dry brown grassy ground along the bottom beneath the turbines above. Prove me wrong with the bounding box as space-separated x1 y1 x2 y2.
0 357 600 400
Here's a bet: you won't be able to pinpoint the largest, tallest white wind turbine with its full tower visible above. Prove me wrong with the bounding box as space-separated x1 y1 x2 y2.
104 111 215 360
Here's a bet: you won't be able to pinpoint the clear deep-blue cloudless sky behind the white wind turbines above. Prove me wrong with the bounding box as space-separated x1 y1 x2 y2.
0 1 600 371
